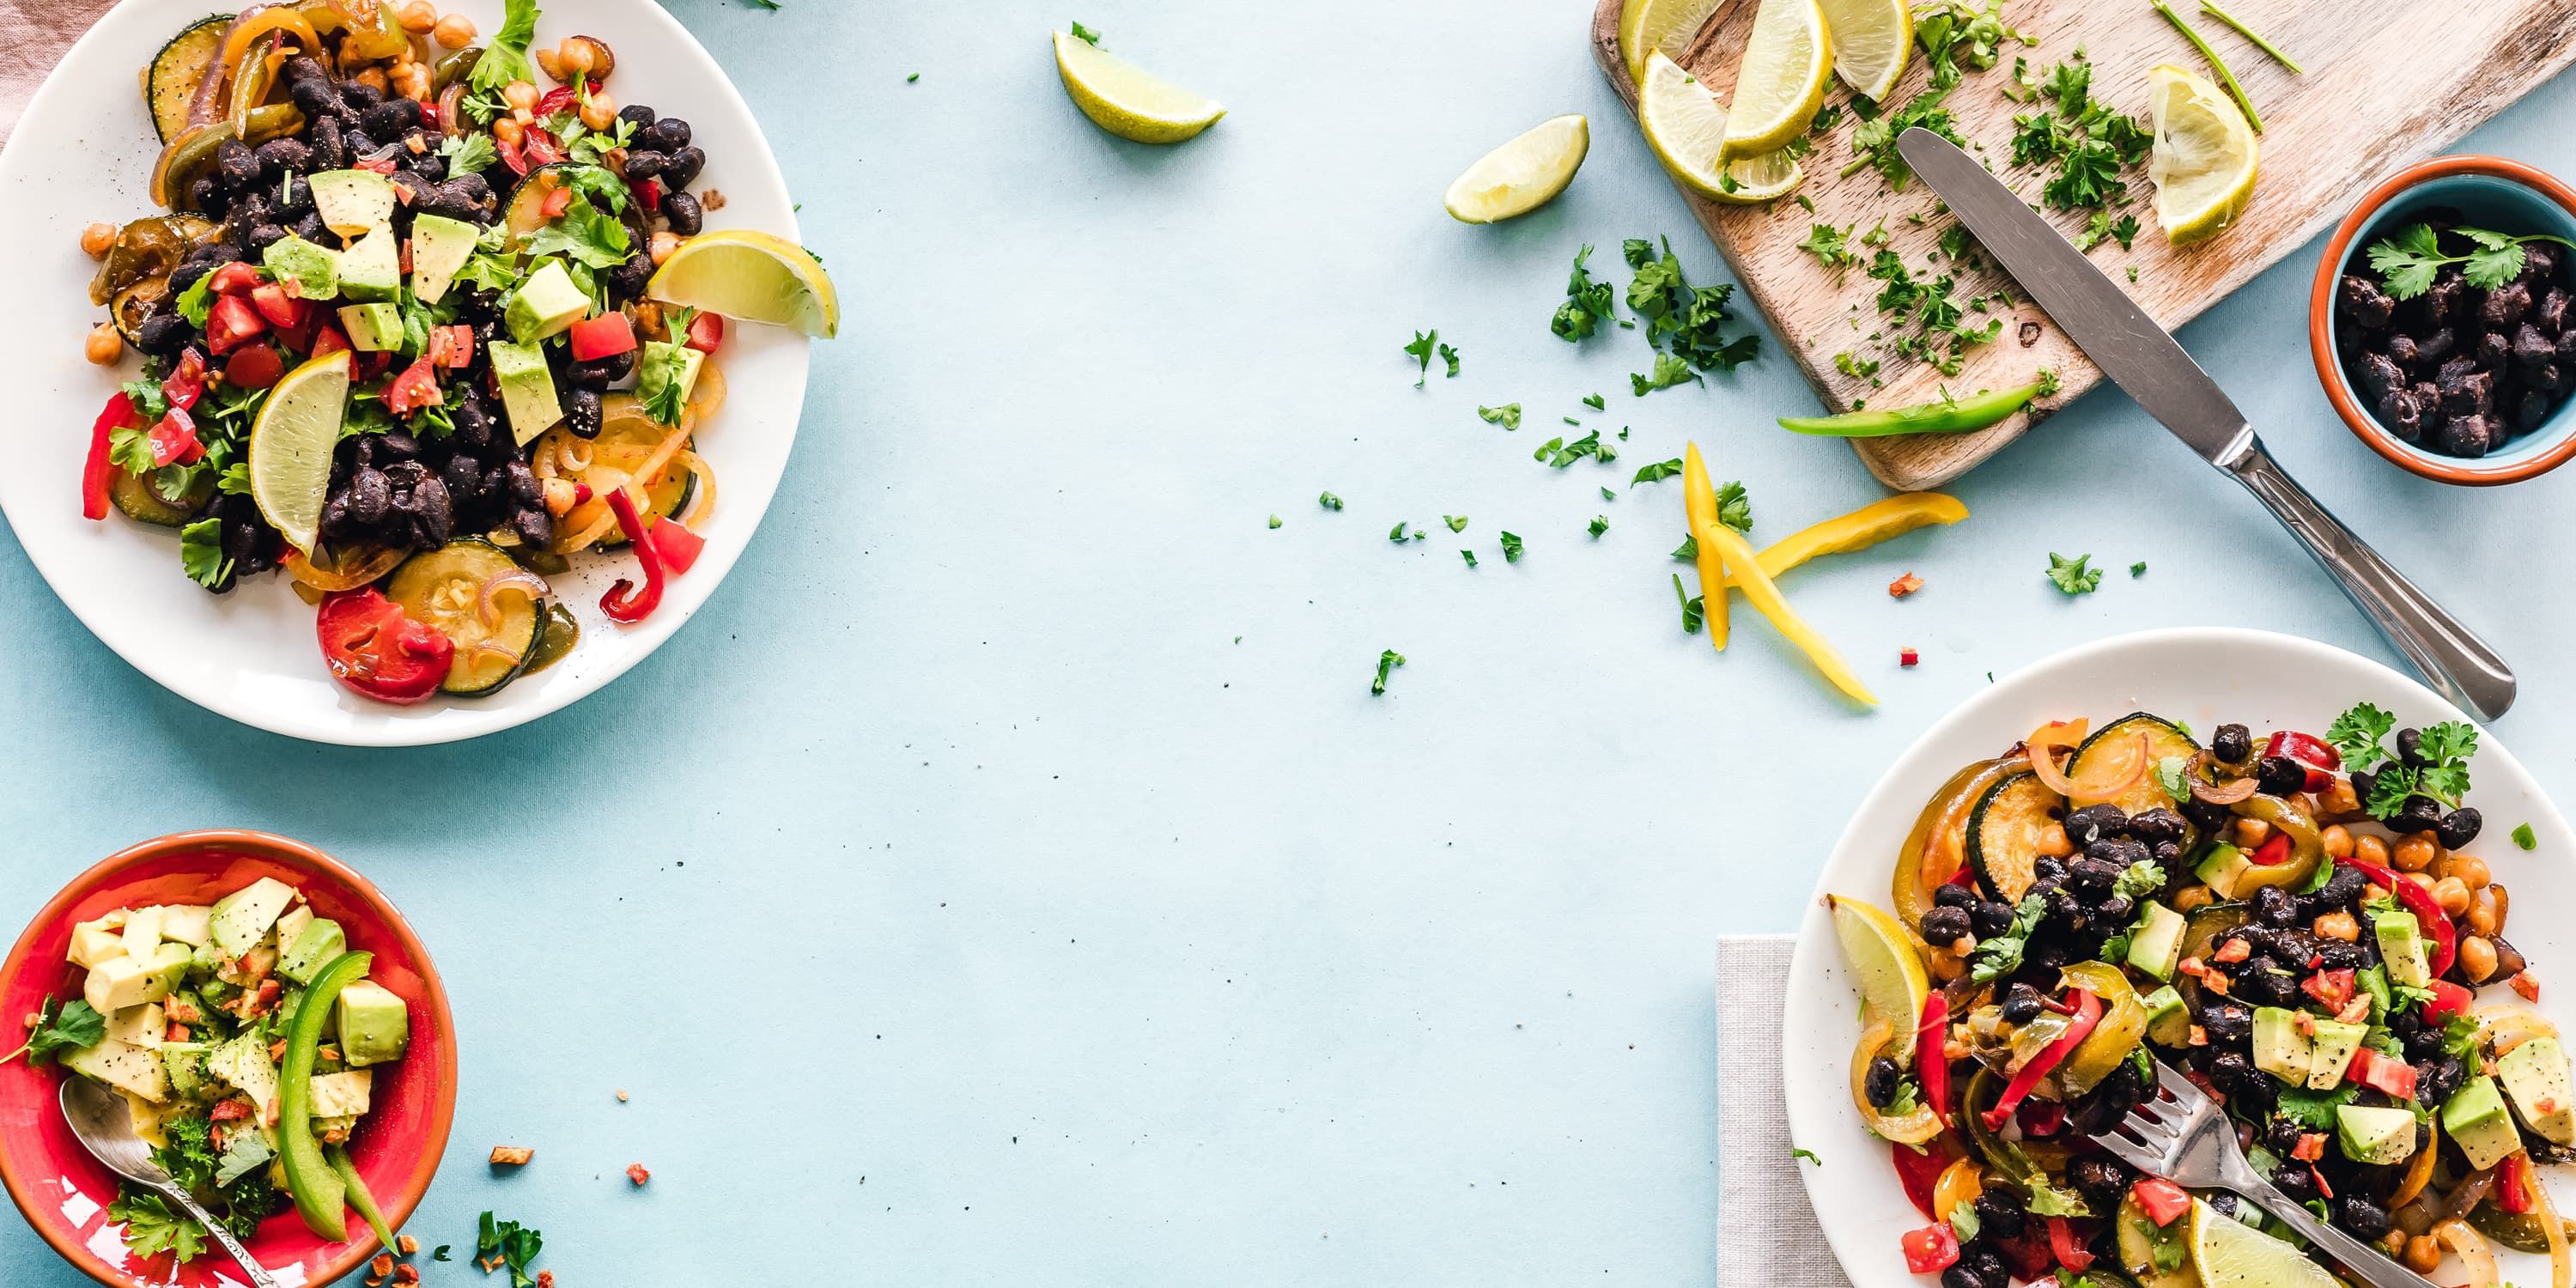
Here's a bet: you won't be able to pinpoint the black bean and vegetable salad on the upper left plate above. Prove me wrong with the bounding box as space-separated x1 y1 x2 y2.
82 0 837 703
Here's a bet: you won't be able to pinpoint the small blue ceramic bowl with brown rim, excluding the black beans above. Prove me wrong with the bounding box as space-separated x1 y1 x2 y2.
2308 157 2576 487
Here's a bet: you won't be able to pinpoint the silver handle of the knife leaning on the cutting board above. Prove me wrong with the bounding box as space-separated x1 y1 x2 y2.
2223 433 2514 721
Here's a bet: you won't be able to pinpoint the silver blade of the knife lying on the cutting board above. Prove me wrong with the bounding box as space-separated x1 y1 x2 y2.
1896 129 2251 464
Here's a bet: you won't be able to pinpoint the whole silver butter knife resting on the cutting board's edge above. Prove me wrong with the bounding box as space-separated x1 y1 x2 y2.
1896 129 2514 719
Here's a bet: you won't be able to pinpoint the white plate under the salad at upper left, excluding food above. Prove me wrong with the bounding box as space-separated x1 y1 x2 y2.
0 0 806 747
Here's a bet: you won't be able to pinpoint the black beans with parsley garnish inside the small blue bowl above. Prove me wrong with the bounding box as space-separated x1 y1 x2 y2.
2334 211 2576 459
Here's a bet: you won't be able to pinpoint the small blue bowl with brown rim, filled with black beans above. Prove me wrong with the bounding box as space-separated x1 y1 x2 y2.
2308 157 2576 484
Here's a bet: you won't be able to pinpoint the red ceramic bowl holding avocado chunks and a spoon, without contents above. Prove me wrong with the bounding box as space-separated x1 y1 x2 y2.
0 829 456 1288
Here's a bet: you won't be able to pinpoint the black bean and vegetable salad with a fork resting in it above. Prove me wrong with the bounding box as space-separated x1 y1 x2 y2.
1832 703 2576 1288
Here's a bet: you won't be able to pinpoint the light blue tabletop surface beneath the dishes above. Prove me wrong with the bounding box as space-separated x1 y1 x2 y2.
0 0 2576 1288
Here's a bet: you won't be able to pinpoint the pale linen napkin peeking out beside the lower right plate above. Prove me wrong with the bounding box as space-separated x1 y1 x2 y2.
1718 935 1852 1288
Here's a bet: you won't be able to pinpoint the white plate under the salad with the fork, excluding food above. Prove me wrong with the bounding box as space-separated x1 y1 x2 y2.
1783 629 2576 1285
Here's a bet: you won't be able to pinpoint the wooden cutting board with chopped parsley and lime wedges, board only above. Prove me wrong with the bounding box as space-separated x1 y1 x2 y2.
1592 0 2576 489
